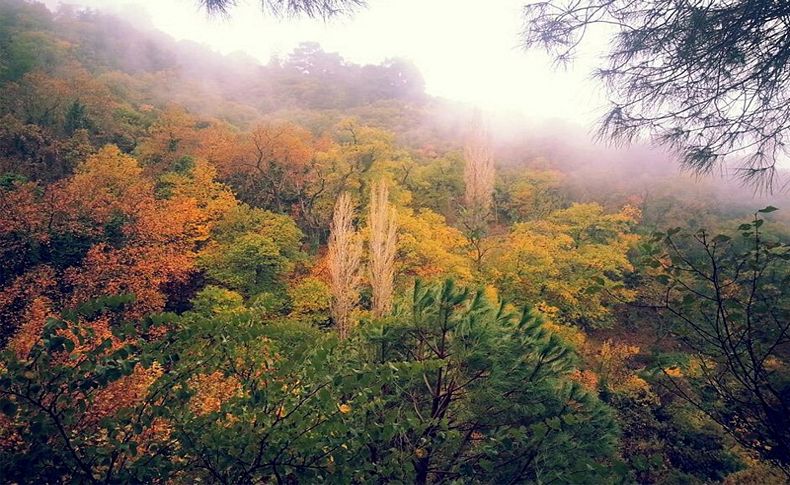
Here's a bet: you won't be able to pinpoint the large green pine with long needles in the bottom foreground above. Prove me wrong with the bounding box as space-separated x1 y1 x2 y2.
361 280 617 484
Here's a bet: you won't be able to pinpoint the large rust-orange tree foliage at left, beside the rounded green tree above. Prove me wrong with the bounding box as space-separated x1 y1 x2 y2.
0 145 236 341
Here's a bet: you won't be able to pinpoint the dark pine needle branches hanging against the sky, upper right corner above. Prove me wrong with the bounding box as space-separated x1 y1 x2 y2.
523 0 790 188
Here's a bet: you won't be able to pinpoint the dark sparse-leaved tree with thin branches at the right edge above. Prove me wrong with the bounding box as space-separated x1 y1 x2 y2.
646 206 790 477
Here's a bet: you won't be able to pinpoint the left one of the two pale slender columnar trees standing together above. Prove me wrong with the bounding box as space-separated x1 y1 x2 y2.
329 193 362 339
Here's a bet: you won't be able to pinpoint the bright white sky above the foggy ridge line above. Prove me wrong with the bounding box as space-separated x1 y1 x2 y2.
45 0 604 125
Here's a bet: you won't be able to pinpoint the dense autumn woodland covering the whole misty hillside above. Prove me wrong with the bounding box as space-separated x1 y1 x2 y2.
0 0 790 484
